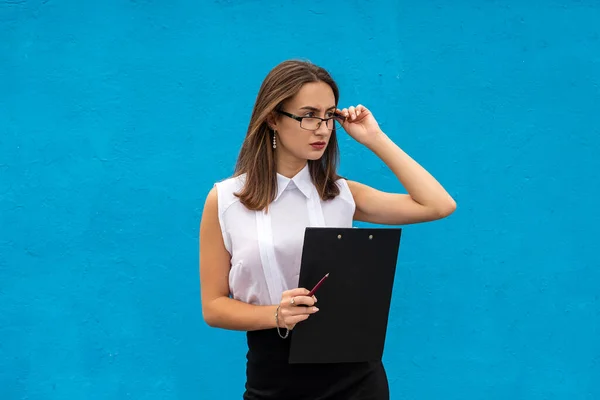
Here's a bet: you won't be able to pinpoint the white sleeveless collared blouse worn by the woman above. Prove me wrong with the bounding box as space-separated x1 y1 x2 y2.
215 165 355 305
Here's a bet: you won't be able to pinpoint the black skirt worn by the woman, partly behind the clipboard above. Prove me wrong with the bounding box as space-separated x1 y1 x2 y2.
244 329 390 400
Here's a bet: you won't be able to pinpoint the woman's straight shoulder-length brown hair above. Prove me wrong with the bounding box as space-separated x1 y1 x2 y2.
235 60 340 210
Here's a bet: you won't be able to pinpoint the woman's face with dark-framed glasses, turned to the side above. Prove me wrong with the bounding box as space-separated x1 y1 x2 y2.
272 82 336 161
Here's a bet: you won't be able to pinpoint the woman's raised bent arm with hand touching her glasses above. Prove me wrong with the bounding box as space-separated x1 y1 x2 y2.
339 105 456 225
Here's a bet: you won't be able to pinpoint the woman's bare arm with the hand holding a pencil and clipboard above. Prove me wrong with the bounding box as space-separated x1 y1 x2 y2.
200 188 316 331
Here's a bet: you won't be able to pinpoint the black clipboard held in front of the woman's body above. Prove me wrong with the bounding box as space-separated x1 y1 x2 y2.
288 227 402 364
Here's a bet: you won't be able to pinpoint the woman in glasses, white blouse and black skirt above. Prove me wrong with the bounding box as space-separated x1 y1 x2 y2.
200 61 456 400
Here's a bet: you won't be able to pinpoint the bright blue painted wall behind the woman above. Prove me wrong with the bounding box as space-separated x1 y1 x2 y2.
0 0 600 400
